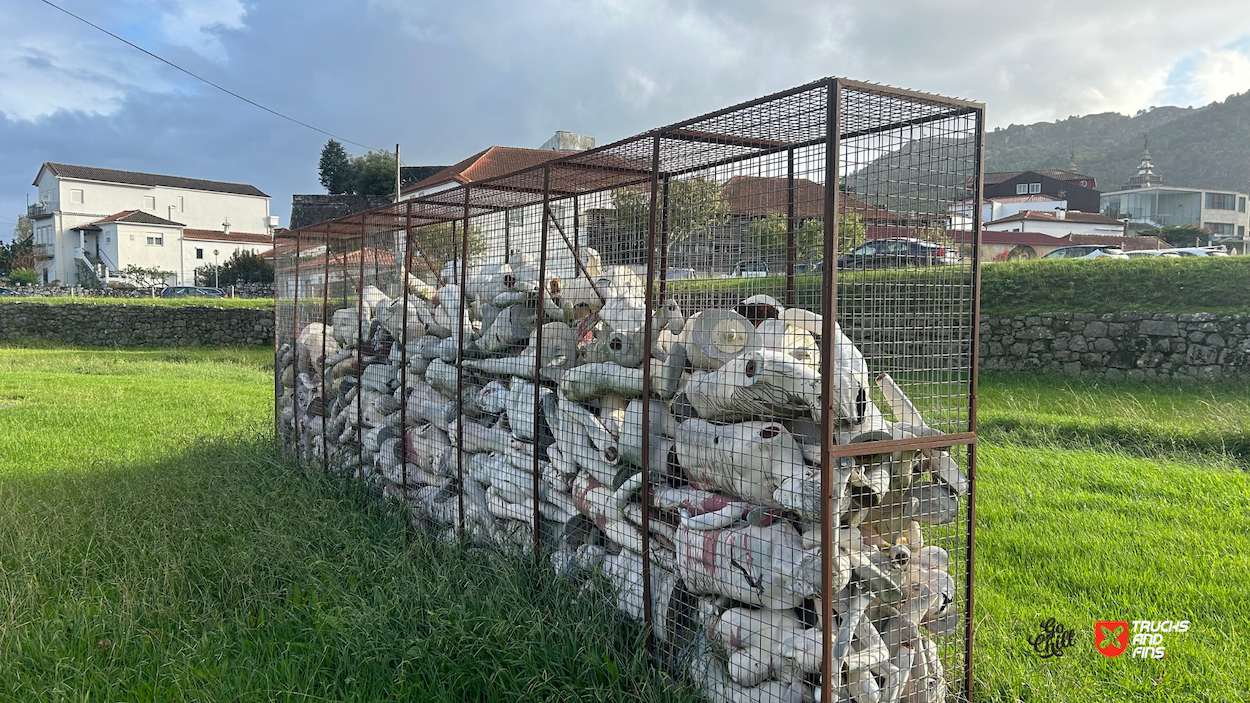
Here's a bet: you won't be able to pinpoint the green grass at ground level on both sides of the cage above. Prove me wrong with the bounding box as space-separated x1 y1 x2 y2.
0 348 1250 703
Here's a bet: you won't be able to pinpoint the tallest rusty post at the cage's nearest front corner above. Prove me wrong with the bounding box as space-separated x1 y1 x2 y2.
820 79 843 700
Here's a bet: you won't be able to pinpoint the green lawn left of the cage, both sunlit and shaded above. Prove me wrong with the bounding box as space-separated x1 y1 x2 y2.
0 348 694 702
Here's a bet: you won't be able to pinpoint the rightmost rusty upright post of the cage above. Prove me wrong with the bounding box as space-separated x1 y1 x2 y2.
964 101 985 703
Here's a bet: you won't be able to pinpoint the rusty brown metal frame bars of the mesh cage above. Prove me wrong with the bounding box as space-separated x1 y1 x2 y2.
274 78 984 700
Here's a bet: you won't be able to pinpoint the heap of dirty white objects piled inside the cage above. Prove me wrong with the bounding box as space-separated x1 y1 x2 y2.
279 249 968 703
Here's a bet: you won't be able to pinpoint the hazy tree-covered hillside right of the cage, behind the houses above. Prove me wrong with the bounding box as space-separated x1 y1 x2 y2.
985 93 1250 193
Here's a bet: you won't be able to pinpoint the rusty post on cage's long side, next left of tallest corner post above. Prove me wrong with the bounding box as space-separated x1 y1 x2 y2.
641 133 660 658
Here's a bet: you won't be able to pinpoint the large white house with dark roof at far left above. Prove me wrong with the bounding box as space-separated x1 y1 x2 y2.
28 163 278 285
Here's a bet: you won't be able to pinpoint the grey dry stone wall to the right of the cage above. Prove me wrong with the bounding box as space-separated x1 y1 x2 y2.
981 310 1250 382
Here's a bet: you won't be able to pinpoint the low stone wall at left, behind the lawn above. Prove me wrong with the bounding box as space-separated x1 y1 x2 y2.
0 301 274 346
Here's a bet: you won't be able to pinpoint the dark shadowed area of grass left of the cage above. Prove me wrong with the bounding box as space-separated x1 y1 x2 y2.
0 438 695 700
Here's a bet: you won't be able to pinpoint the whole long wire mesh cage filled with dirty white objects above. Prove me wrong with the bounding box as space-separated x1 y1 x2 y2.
275 79 983 702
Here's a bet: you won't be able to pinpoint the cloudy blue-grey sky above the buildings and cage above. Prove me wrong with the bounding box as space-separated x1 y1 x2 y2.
0 0 1250 238
